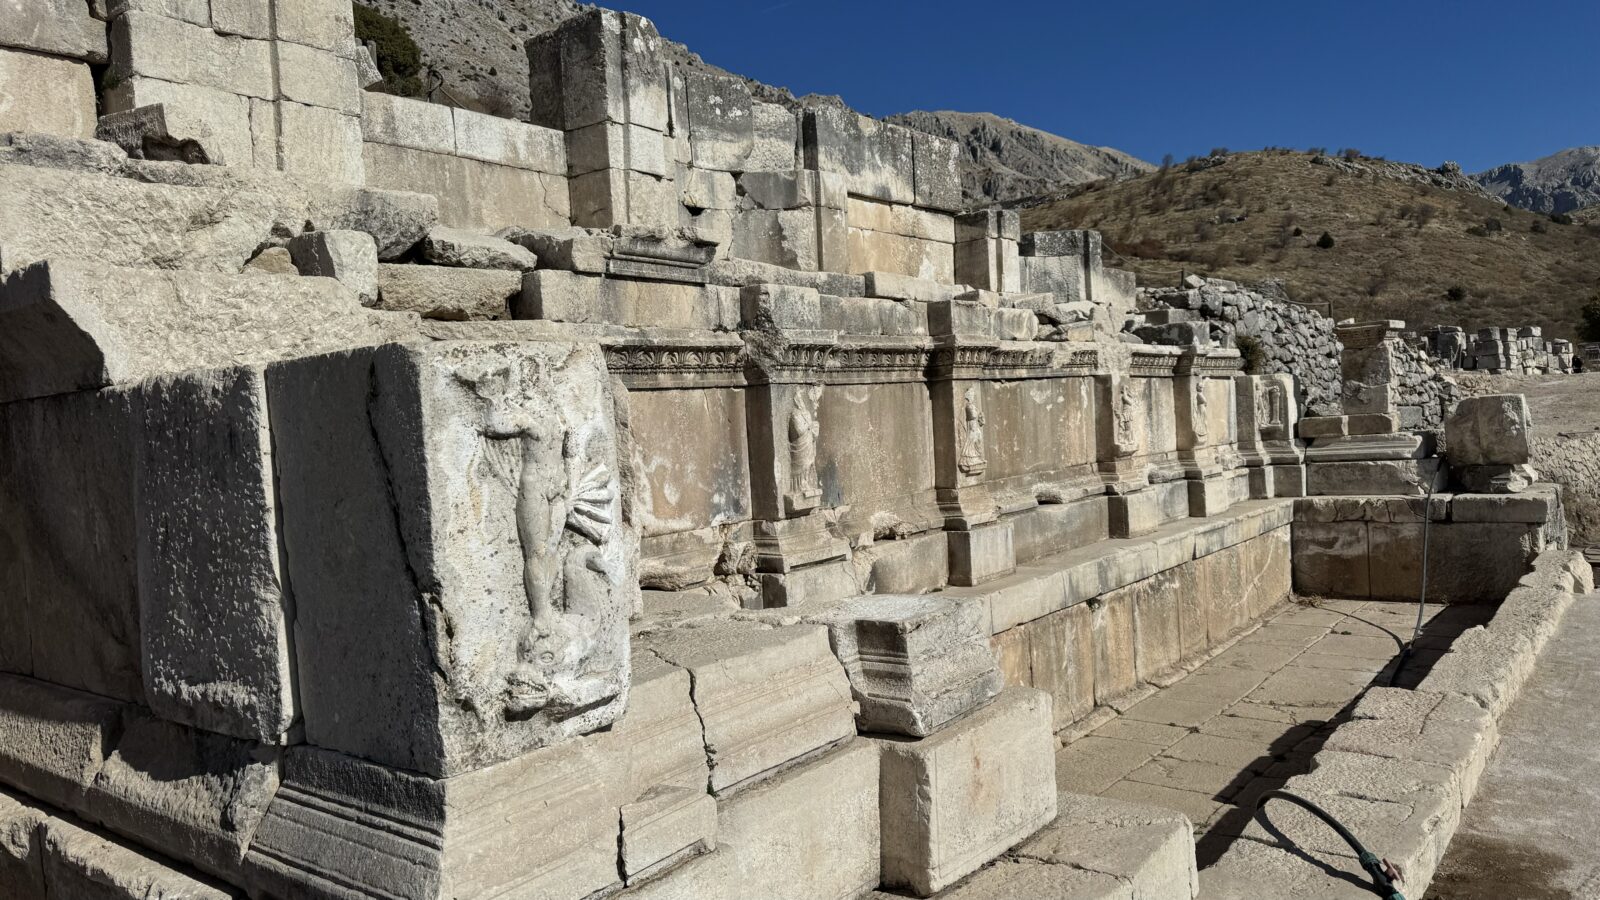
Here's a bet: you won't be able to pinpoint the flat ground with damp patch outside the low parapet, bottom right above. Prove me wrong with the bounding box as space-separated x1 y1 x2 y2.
1427 594 1600 900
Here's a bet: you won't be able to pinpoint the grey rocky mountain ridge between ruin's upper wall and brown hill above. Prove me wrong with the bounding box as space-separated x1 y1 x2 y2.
888 112 1155 205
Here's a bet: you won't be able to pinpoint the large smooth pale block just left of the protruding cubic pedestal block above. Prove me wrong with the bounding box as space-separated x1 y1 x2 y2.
627 738 880 900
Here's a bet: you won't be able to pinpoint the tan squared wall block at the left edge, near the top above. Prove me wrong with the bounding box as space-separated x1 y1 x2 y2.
0 48 94 138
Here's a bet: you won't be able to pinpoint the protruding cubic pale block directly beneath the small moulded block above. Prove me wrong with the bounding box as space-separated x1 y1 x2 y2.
880 687 1056 897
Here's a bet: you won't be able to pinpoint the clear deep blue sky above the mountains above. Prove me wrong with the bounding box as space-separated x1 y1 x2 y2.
603 0 1600 171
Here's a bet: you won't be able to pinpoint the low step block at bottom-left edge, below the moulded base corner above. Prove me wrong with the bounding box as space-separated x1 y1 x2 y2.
43 818 232 900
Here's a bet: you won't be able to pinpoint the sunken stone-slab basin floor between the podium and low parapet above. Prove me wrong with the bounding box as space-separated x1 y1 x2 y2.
1056 601 1493 868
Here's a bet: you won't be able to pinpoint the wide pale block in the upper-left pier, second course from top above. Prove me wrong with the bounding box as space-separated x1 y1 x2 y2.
110 12 275 98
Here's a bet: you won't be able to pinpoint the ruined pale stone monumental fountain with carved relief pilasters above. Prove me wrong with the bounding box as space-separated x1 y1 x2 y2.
0 0 1592 900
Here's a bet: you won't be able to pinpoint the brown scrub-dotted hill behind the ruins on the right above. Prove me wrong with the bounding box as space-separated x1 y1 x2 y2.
1022 151 1600 338
